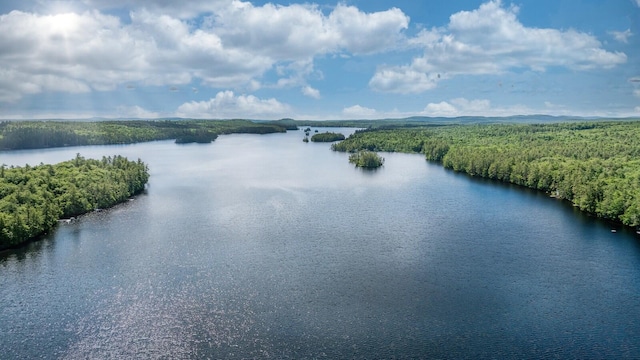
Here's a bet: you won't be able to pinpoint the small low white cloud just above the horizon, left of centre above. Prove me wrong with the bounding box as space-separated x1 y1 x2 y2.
176 90 291 119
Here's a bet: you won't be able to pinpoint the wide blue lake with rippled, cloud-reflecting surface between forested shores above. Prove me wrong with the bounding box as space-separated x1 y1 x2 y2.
0 132 640 359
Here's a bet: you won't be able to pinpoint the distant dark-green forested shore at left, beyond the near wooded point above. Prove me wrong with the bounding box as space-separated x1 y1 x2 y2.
0 120 286 150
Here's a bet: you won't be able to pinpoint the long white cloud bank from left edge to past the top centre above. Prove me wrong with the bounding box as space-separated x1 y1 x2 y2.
0 0 409 102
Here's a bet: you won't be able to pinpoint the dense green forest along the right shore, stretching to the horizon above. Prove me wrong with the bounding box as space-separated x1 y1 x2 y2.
332 121 640 226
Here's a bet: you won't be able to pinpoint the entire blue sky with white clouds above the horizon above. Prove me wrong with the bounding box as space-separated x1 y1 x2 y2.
0 0 640 120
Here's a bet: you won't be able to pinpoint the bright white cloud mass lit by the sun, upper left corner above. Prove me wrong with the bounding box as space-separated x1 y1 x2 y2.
0 11 190 99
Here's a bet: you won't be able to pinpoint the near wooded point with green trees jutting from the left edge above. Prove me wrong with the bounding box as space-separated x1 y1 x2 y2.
0 154 149 250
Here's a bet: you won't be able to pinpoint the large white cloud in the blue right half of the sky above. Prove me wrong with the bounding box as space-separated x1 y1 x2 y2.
369 0 627 93
